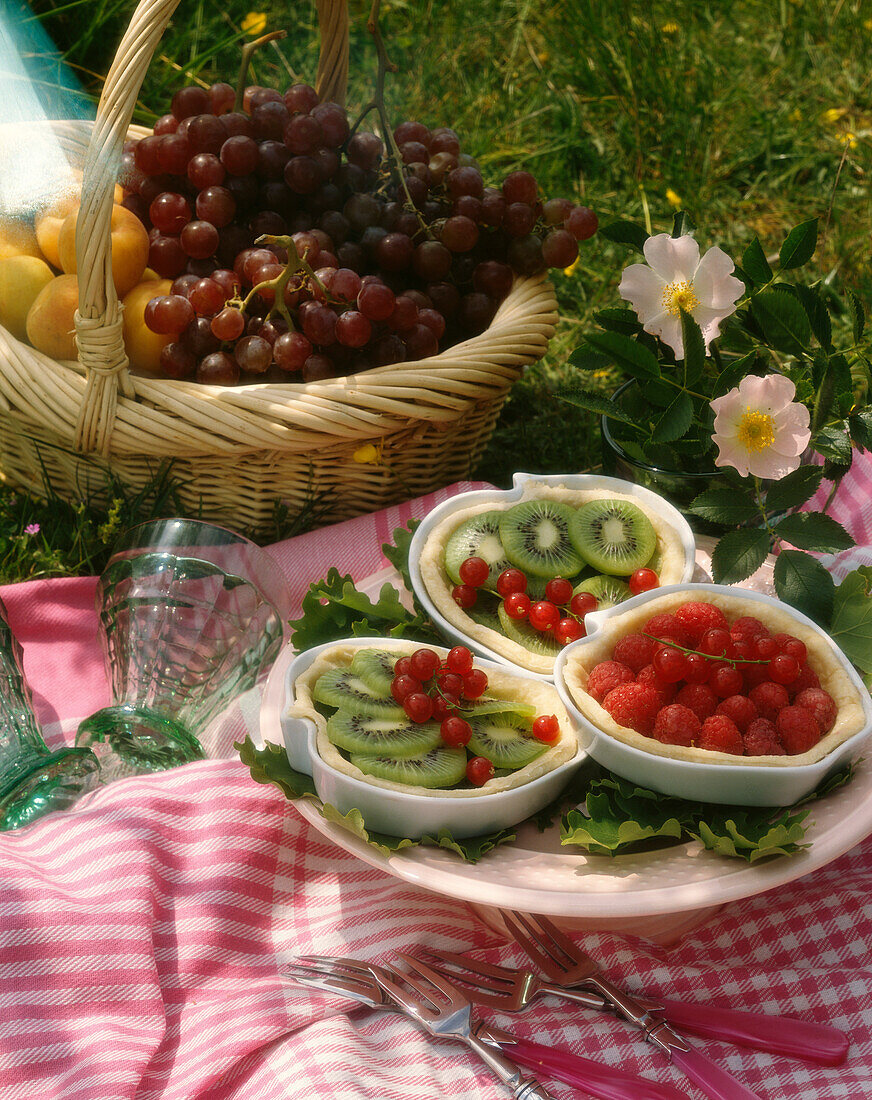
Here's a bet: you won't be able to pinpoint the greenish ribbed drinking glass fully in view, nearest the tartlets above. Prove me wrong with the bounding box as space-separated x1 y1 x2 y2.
76 519 290 778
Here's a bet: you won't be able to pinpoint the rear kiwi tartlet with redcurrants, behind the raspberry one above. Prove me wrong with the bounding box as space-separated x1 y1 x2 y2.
418 477 693 675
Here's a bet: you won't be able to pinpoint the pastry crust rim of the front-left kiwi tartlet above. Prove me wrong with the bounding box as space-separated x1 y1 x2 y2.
287 639 581 799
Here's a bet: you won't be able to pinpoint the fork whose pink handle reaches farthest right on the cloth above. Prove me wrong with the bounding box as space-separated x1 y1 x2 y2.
426 946 849 1066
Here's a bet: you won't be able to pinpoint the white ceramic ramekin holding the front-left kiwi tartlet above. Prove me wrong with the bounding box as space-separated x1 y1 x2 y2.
282 638 585 839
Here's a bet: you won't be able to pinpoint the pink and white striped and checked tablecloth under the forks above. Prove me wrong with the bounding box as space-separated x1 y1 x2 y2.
0 466 872 1100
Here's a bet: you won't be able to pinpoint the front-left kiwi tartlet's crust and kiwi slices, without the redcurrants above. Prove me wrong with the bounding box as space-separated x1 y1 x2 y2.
288 639 578 799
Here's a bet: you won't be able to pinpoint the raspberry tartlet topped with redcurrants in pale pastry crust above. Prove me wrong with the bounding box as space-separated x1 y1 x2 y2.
561 585 869 768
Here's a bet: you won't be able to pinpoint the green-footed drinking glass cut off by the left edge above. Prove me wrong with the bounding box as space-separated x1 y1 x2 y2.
0 600 100 829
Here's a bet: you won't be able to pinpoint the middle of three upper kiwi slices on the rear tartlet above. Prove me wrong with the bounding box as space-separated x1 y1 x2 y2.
499 501 584 579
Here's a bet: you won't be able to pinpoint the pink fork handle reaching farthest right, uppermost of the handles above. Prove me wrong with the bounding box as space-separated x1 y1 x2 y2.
658 1001 851 1066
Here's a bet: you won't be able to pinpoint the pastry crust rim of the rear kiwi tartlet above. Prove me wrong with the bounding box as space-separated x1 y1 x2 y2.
420 484 685 675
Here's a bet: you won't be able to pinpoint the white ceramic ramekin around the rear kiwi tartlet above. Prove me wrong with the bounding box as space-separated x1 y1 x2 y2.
409 473 696 681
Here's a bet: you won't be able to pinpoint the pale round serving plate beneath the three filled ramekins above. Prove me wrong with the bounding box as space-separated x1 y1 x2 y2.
261 539 872 938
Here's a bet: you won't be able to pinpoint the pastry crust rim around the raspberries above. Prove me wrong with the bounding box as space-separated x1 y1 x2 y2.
563 591 865 768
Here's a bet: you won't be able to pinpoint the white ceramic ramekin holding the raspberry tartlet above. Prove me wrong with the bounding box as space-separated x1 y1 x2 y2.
554 584 872 806
